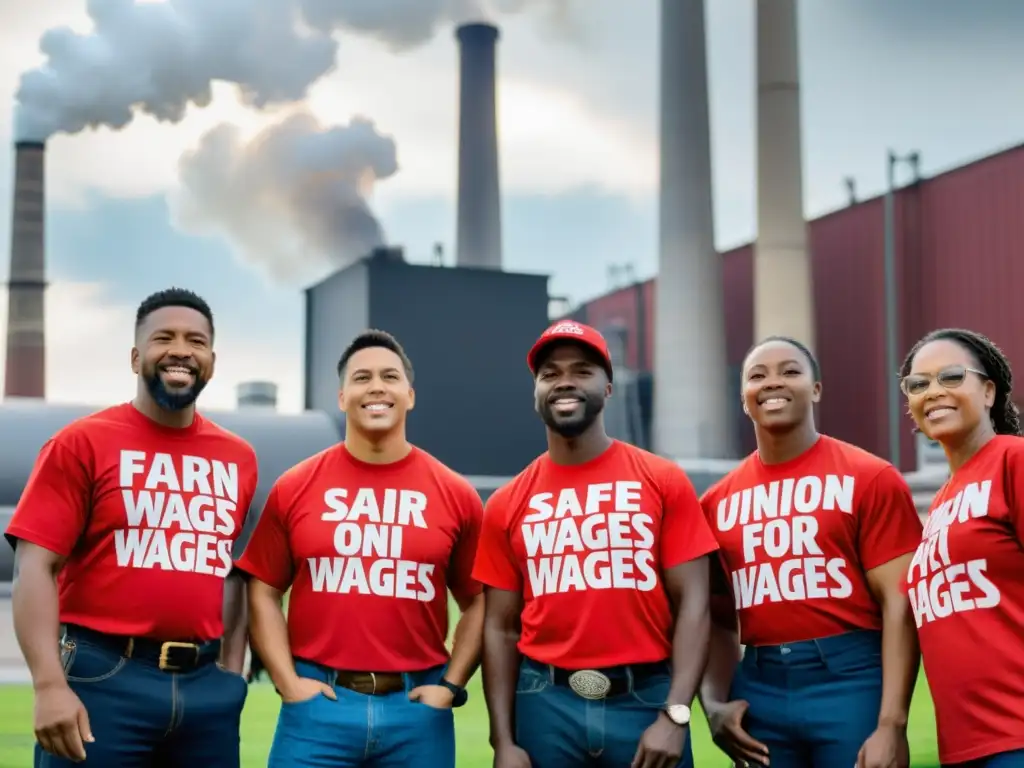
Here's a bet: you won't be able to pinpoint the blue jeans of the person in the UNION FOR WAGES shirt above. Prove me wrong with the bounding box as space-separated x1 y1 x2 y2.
731 631 882 768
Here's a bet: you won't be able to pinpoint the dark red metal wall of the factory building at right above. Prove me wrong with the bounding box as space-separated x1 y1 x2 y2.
574 146 1024 469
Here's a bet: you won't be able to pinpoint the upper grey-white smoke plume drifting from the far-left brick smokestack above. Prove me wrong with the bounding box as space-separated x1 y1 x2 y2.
16 0 338 141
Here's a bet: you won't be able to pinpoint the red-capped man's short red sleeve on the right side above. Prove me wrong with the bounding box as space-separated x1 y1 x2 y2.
660 465 718 568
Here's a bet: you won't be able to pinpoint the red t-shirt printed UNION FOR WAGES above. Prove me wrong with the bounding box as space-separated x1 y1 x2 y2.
701 435 921 645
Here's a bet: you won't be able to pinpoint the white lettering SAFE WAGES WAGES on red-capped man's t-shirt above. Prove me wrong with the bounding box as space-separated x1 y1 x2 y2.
521 480 657 597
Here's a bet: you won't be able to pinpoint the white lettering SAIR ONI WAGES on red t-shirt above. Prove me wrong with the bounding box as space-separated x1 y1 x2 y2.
307 488 437 602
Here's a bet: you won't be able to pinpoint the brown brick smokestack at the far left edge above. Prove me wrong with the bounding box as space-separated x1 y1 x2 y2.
4 141 46 397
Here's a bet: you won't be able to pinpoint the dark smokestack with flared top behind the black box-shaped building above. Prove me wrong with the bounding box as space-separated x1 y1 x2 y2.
456 24 502 269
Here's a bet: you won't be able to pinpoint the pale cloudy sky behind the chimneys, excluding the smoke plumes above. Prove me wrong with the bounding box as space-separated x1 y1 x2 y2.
0 0 1024 411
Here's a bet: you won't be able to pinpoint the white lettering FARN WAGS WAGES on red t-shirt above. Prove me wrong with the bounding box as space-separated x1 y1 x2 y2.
114 451 239 579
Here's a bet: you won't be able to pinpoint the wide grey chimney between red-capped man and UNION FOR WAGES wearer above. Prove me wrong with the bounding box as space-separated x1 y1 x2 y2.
653 0 739 459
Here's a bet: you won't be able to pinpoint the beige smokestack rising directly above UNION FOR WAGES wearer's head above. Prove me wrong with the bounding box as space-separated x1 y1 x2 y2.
754 0 814 349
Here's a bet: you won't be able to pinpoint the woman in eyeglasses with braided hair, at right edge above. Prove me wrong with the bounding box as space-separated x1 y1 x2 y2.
900 329 1024 768
